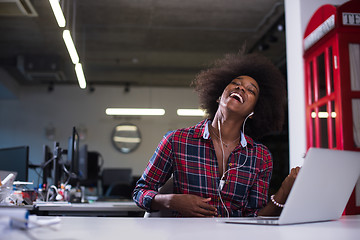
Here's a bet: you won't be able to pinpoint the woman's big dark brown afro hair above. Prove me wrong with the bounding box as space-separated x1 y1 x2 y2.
192 51 286 139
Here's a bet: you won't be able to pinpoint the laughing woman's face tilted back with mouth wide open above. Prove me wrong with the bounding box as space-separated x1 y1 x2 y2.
220 76 260 117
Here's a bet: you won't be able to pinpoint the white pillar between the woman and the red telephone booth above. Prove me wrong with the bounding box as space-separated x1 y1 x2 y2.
285 0 347 168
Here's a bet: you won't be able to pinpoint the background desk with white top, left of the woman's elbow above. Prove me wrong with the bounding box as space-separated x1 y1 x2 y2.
34 201 144 217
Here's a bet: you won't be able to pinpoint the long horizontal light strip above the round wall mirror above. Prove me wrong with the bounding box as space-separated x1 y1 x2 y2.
105 108 165 116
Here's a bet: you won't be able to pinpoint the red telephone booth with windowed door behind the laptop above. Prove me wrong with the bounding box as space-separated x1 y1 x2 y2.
303 0 360 214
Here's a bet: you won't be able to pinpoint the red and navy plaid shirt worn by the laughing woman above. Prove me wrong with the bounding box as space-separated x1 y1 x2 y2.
133 120 272 217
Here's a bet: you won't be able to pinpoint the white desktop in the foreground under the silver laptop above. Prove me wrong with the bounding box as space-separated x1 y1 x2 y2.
0 215 360 240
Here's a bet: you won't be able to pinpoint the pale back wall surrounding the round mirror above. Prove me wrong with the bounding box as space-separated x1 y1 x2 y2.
0 85 202 182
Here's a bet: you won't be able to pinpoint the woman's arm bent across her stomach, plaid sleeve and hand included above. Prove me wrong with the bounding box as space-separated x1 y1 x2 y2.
133 132 217 217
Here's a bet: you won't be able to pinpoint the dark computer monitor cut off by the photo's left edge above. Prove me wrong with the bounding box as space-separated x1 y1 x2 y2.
0 146 29 182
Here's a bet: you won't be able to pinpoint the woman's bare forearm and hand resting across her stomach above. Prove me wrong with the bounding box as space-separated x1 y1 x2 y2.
152 194 217 217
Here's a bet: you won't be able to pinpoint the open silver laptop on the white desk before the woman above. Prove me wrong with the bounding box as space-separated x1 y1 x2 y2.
222 148 360 225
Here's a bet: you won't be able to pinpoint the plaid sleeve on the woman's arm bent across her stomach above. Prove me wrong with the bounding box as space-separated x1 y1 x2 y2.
133 132 173 212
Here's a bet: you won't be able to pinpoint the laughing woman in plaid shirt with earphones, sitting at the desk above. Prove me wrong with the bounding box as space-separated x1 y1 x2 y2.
133 53 299 217
